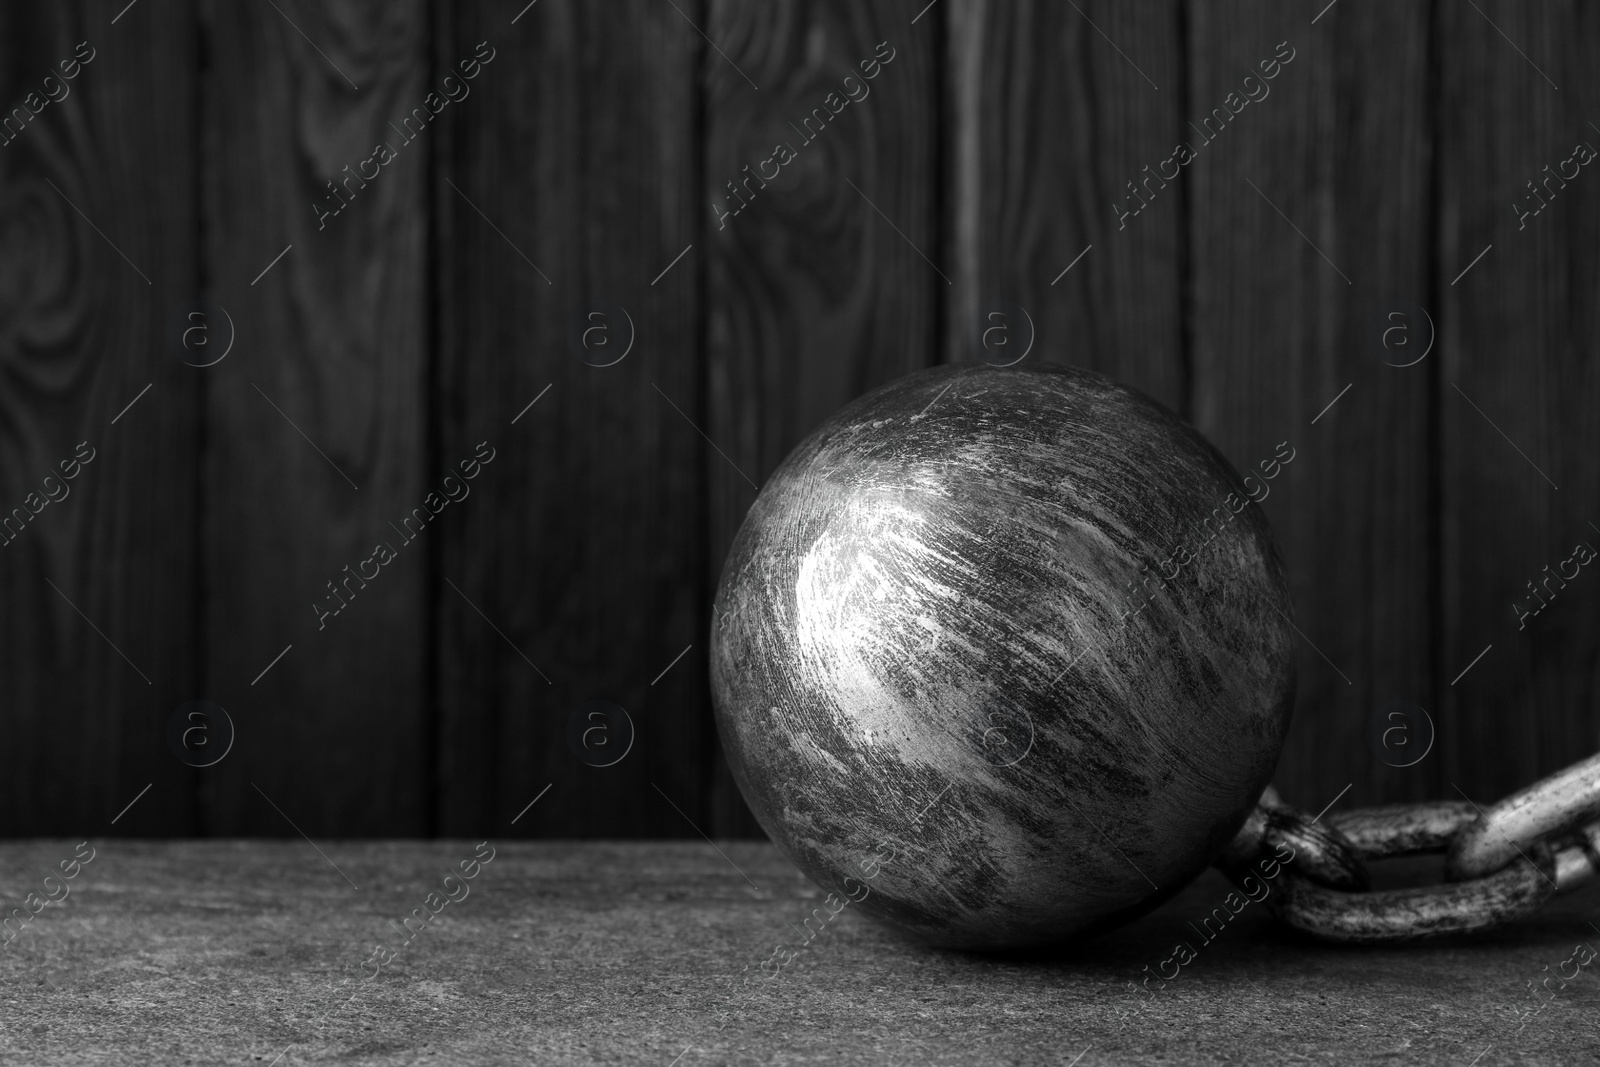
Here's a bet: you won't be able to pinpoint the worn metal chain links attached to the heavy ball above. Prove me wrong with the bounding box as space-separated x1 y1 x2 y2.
1216 755 1600 942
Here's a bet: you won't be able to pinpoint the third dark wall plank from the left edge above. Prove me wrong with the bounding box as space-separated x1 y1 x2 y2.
435 0 710 837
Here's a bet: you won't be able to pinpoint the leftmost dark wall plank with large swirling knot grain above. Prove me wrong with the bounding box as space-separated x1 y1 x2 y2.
0 0 197 831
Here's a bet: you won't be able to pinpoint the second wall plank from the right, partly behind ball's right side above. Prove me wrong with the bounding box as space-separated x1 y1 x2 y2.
1186 2 1446 811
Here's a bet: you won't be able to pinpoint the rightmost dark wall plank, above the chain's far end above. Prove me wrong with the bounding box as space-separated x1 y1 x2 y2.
1440 3 1600 801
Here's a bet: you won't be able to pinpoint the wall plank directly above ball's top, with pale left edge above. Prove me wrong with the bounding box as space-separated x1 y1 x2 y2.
934 0 1189 413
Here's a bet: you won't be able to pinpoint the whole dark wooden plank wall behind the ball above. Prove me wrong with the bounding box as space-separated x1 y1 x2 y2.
0 0 1600 837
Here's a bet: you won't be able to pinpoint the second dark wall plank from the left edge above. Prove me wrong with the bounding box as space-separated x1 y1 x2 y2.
202 0 435 831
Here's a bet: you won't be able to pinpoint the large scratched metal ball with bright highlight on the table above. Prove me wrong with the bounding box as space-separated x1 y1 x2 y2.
710 365 1294 949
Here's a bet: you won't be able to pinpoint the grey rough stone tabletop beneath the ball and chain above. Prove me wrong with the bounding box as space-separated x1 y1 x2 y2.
0 840 1600 1067
